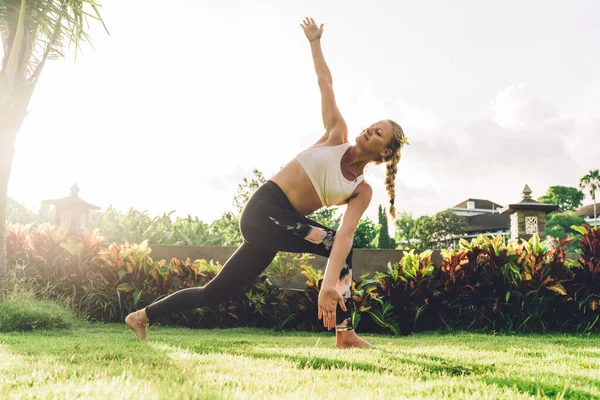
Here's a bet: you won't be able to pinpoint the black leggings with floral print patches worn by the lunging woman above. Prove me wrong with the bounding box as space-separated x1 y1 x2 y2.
146 181 352 331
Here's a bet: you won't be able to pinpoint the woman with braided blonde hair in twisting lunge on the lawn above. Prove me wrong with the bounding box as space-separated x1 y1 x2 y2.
125 18 407 348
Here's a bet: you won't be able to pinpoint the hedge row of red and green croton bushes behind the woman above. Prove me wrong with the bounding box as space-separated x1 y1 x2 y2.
7 225 600 335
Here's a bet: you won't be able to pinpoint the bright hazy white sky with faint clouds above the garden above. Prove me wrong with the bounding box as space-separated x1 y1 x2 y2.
8 0 600 222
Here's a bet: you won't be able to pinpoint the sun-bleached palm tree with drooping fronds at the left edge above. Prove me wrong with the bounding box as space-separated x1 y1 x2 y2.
0 0 106 295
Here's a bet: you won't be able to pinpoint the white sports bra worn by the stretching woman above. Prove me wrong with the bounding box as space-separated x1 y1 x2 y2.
296 143 364 206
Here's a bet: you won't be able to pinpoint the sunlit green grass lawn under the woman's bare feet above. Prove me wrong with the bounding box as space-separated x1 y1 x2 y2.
0 324 600 400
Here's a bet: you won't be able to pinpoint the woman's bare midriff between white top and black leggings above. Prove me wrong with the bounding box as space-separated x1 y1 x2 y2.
271 159 323 215
